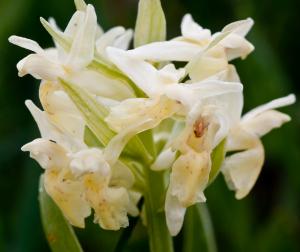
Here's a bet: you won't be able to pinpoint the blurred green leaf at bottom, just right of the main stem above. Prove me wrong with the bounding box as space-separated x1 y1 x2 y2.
183 203 217 252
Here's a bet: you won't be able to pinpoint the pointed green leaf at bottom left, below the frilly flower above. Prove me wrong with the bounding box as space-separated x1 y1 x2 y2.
39 176 83 252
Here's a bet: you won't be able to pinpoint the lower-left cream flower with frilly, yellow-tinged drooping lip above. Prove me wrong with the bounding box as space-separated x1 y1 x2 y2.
22 99 138 230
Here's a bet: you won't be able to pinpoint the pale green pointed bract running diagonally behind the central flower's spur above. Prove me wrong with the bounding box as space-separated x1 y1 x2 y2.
60 79 152 163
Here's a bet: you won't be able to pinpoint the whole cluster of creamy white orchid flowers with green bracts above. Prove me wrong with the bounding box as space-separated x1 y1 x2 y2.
9 0 295 235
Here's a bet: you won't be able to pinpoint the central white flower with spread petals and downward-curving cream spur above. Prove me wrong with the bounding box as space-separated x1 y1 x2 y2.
102 48 242 165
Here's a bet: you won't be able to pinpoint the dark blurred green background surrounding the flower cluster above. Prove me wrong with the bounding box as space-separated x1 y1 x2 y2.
0 0 300 252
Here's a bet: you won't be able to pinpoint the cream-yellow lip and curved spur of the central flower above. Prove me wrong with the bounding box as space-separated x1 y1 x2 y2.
104 97 180 165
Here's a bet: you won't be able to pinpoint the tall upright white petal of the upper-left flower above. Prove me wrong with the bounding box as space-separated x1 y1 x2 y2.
66 4 97 70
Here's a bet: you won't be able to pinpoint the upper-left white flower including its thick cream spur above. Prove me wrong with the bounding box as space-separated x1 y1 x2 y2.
9 5 135 100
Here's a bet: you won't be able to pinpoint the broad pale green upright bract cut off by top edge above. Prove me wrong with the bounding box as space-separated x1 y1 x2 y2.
134 0 166 47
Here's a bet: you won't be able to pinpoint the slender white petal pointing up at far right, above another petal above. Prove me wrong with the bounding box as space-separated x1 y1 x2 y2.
242 94 296 122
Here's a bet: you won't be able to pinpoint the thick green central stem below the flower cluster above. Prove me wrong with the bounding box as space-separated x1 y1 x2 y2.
145 169 173 252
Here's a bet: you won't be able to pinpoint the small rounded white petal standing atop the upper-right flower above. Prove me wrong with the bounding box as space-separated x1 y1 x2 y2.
181 14 211 42
